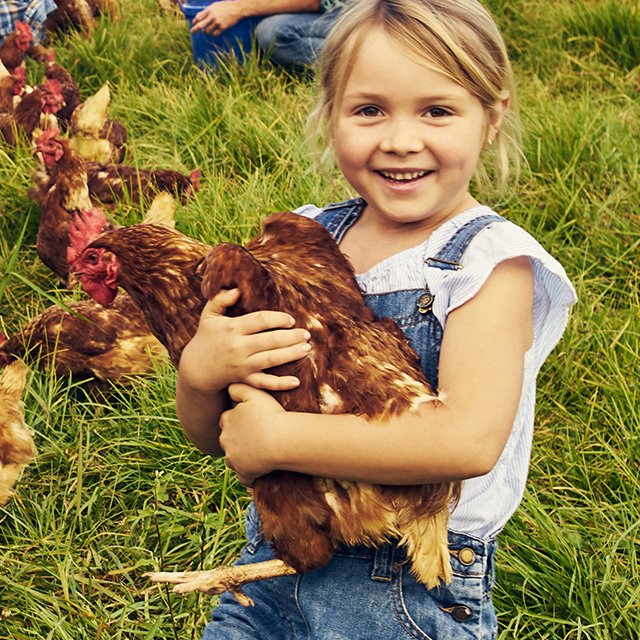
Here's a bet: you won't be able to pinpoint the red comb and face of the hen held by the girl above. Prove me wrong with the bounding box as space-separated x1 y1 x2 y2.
67 209 119 305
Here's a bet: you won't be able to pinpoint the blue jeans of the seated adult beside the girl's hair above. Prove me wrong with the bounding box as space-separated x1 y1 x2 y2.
255 9 339 69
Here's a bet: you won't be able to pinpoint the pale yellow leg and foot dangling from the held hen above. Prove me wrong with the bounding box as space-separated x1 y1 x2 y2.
145 559 296 607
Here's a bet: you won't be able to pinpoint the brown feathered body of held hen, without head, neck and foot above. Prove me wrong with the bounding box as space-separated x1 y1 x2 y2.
203 213 460 586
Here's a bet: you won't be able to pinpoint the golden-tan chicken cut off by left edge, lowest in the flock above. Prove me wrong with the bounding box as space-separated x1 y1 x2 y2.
0 360 36 507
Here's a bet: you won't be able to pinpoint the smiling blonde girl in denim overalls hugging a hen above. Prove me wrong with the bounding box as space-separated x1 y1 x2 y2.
176 0 575 640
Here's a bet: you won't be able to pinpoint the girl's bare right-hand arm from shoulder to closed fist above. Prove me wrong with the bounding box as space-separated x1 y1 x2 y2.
220 258 533 484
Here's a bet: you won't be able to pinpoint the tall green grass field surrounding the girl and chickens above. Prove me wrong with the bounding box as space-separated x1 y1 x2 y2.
0 0 640 640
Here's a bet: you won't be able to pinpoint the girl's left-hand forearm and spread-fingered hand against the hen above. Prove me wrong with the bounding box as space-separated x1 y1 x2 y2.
176 289 311 456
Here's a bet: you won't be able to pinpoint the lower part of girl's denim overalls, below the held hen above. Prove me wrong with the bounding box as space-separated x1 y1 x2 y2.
202 505 497 640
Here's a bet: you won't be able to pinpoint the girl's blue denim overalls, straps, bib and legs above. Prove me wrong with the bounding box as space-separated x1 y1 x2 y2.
203 198 503 640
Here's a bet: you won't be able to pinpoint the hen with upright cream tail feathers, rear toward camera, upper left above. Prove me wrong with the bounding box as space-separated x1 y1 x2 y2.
69 84 127 164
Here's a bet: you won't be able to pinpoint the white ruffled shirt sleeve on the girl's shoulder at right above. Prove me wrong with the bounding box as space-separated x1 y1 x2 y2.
432 221 577 367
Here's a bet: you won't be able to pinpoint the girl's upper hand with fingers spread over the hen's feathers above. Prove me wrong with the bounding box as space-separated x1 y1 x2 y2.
180 289 311 393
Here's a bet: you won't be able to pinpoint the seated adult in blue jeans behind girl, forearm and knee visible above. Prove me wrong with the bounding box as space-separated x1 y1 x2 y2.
191 0 342 69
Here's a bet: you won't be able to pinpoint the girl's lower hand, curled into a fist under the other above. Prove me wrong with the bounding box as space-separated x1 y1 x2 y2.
220 384 284 487
